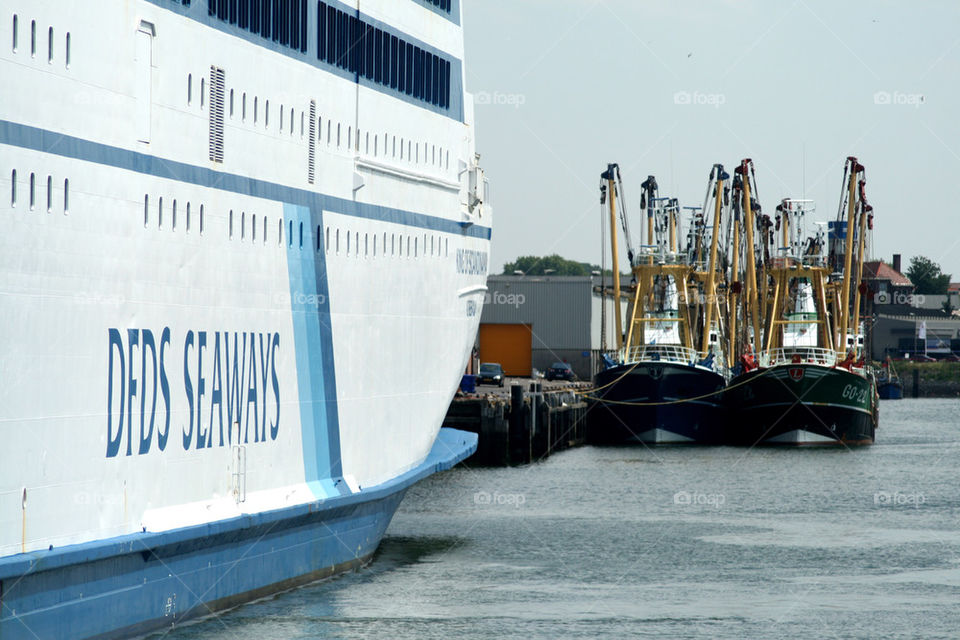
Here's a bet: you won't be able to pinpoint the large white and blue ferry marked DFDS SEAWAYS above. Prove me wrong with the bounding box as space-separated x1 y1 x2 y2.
0 0 492 640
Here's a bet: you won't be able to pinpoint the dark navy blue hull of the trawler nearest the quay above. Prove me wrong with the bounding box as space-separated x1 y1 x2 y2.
589 363 726 444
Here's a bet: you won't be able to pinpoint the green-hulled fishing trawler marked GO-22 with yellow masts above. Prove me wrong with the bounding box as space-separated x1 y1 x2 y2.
725 158 878 446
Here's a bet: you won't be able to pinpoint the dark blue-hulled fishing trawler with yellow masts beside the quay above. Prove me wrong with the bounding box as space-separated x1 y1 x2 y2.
590 165 728 444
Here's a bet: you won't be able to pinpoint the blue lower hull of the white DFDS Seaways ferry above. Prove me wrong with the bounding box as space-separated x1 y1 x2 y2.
0 429 477 640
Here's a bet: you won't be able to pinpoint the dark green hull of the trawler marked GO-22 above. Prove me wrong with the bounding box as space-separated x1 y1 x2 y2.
725 364 877 446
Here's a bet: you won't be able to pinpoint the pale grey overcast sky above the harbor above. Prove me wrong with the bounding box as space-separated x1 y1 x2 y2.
464 0 960 281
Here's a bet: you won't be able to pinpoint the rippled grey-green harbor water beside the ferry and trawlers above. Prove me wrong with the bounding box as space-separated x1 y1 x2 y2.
165 400 960 640
